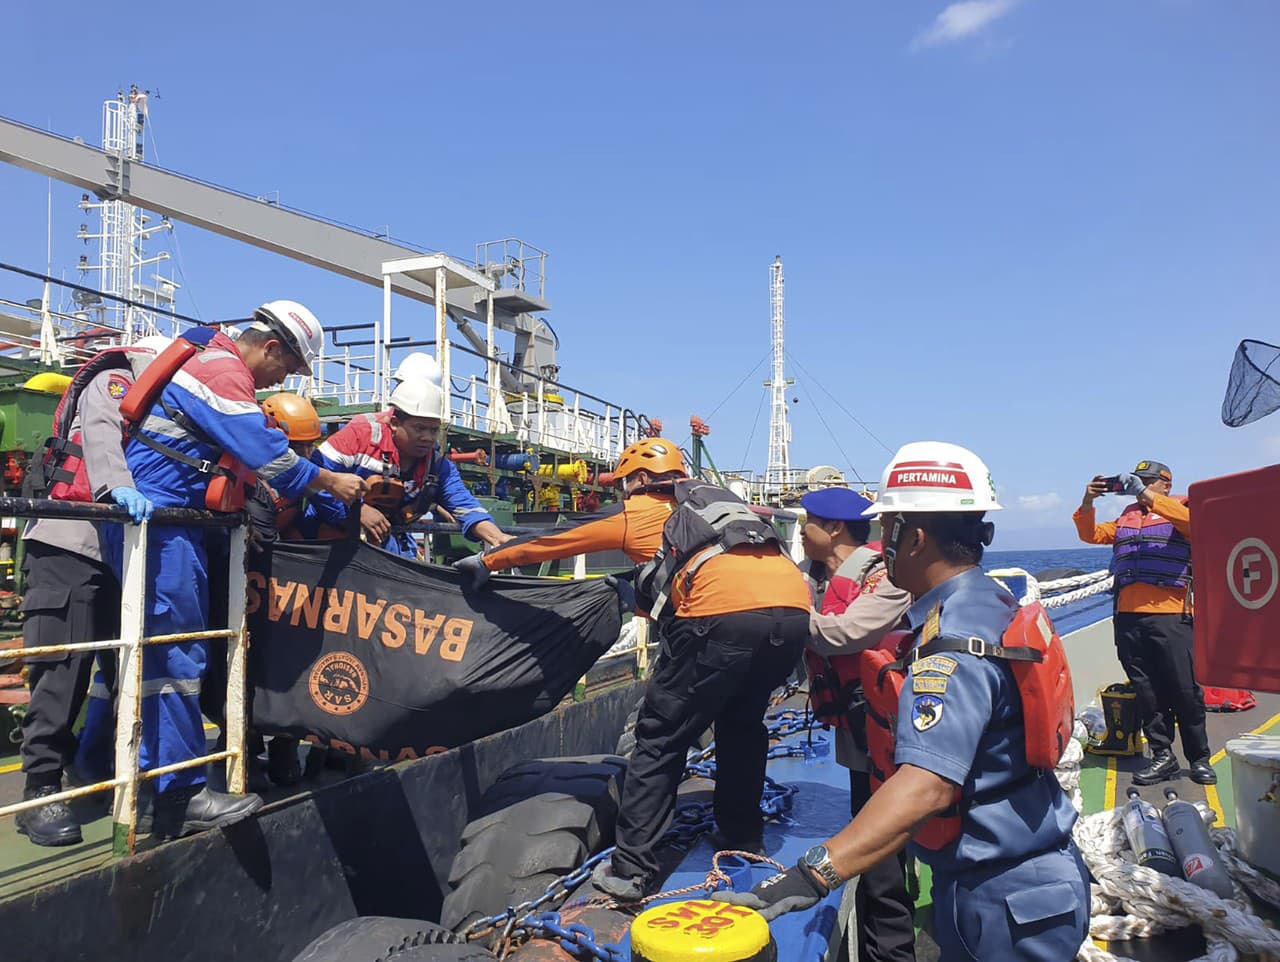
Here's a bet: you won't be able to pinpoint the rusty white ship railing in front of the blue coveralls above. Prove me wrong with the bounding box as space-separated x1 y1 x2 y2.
0 498 248 856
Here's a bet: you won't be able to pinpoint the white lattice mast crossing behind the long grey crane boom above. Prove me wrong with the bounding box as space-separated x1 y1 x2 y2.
78 84 178 344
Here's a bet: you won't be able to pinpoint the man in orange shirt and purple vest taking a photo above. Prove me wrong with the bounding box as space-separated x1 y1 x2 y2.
1071 461 1217 785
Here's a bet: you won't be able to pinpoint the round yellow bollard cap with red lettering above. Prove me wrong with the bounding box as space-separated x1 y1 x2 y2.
631 899 777 962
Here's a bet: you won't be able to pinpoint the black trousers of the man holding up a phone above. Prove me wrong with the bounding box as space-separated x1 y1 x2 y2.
1115 611 1210 761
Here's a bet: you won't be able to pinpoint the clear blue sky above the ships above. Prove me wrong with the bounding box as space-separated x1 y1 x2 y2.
0 0 1280 548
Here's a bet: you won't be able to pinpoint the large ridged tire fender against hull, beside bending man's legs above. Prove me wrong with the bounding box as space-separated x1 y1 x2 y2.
440 755 626 931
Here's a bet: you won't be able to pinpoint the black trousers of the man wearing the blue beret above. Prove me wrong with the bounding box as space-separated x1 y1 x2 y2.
849 771 915 962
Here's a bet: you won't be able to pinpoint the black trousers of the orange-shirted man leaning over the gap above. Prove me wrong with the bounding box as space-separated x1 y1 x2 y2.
613 608 809 879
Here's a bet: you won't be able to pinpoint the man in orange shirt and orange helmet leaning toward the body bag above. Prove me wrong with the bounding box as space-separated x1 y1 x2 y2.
457 438 809 901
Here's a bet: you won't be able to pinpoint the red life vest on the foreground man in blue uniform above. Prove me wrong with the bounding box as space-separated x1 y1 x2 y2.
861 603 1075 851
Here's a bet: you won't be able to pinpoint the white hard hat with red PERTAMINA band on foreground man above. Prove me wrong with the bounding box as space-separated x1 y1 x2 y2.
863 441 1001 517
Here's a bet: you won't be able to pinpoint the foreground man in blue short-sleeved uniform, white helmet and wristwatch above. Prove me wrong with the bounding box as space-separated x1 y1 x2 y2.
716 441 1089 962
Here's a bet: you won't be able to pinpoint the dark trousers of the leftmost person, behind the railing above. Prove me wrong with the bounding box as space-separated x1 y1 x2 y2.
22 541 120 788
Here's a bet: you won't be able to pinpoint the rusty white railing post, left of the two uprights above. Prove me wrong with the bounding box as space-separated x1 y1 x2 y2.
111 522 148 858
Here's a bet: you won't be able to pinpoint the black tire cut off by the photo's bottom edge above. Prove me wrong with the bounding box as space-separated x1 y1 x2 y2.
293 916 494 962
